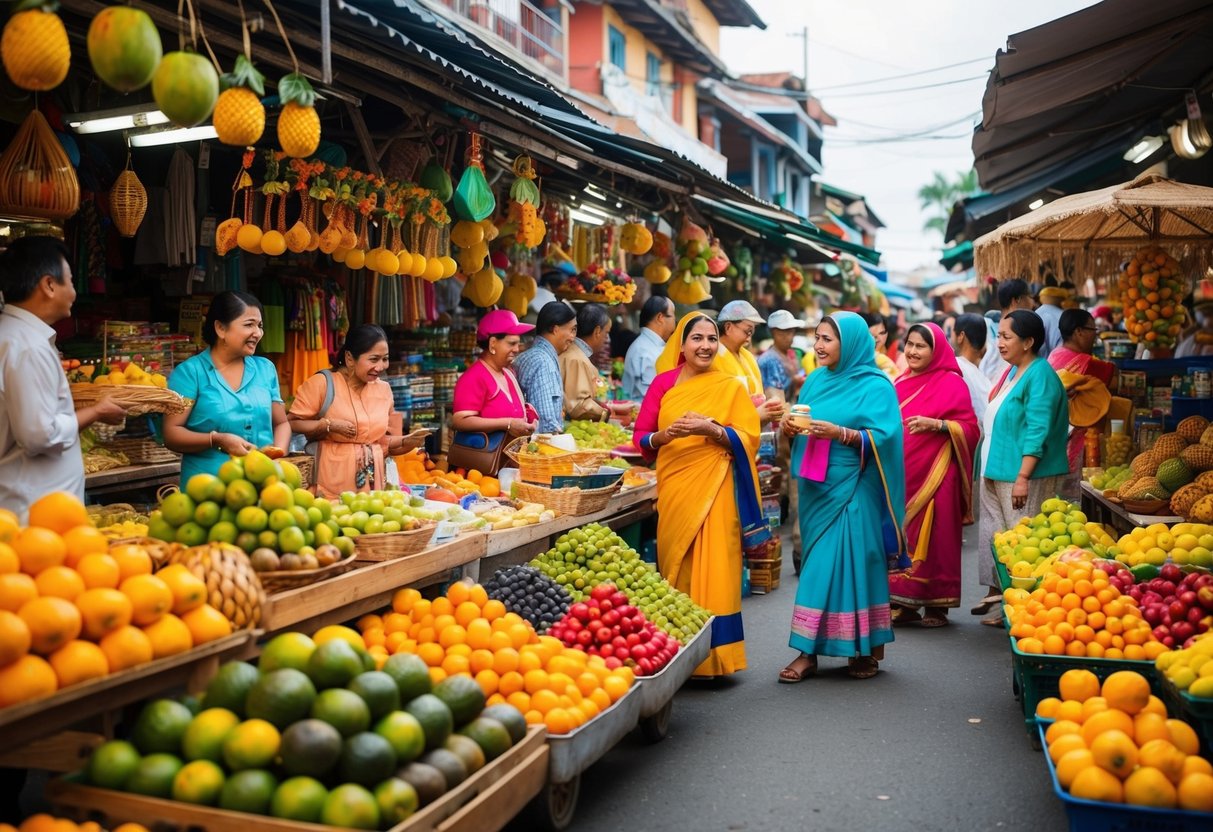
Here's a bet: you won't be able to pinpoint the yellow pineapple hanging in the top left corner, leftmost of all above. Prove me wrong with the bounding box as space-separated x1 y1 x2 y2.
0 0 72 92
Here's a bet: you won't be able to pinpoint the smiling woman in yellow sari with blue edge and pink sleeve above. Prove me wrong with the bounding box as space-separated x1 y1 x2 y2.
634 313 770 677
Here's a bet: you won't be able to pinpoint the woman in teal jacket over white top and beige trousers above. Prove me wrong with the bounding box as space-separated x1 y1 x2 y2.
974 309 1070 627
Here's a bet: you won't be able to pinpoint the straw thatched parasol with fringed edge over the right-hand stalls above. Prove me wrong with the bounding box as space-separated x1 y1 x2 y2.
973 173 1213 279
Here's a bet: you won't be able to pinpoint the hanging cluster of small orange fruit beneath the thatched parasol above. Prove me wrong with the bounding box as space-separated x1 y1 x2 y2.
1120 246 1188 348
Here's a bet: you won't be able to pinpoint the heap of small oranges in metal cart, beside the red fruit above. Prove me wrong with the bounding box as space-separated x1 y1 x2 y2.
358 582 634 734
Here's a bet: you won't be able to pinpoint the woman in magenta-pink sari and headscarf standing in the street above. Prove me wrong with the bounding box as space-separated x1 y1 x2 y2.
889 324 980 627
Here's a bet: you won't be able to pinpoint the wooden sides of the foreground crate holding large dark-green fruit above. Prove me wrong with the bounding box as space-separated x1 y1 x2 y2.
46 725 548 832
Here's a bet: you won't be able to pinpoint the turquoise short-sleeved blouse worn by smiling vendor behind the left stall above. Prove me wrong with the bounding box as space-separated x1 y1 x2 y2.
169 349 283 484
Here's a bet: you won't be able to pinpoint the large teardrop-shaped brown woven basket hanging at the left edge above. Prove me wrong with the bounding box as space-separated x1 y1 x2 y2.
0 110 80 220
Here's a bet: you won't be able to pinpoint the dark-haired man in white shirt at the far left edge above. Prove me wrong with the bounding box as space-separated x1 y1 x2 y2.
0 237 126 523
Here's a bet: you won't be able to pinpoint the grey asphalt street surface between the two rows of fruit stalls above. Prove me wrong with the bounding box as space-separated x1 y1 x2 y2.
543 526 1067 832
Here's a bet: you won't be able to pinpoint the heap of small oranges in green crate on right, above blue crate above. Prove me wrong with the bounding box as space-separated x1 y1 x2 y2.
1003 562 1167 661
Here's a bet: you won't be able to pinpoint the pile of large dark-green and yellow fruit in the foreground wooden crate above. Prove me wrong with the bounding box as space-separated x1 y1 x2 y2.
85 627 526 830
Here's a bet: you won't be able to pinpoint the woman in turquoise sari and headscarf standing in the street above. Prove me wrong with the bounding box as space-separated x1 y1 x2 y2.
779 312 905 683
